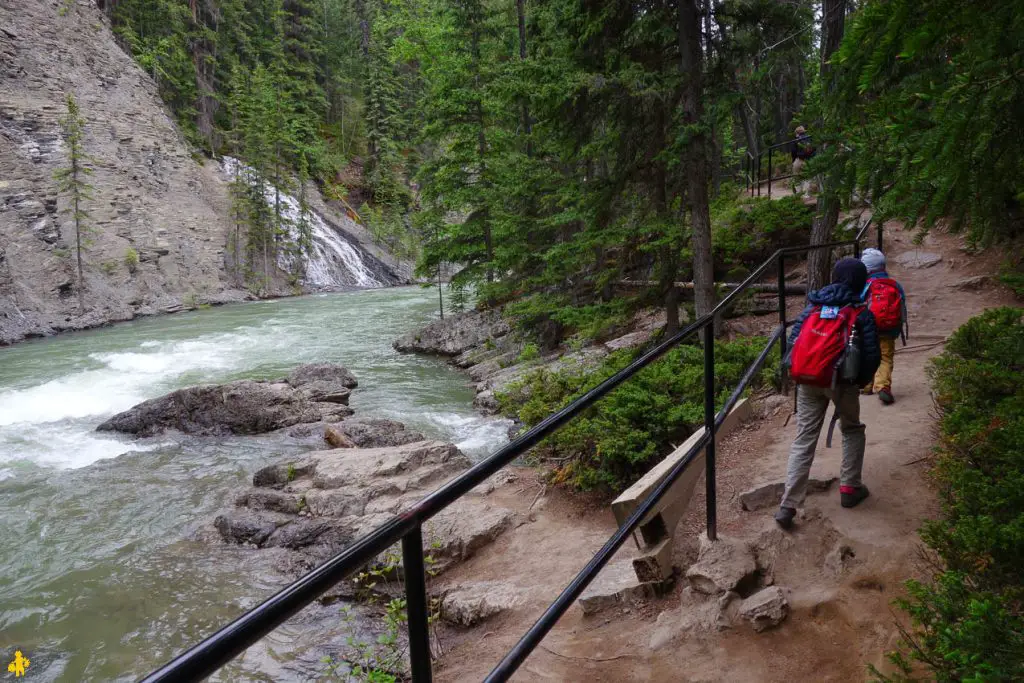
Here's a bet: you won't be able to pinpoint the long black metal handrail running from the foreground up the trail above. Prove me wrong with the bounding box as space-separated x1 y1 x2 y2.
143 221 882 683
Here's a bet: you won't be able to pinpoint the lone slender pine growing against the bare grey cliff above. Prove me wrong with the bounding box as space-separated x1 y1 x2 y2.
54 93 92 313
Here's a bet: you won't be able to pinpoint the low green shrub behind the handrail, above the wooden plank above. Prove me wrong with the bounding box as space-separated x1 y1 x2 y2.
498 338 777 493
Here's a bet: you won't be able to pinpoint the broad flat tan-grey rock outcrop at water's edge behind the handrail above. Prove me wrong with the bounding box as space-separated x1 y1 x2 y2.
214 440 517 573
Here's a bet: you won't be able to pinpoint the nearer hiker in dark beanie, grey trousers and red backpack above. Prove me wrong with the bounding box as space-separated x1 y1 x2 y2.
775 258 881 529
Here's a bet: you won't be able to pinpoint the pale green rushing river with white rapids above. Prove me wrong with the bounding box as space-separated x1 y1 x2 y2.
0 288 505 681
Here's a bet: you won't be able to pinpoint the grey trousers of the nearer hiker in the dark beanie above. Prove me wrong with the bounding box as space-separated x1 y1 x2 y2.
781 384 864 509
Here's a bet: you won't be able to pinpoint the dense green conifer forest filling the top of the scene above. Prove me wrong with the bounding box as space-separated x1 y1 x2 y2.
103 0 1024 328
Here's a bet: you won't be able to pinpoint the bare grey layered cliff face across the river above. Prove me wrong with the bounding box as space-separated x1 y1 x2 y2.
0 0 410 345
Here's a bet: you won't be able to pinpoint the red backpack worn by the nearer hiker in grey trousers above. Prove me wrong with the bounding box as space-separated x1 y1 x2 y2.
790 306 860 389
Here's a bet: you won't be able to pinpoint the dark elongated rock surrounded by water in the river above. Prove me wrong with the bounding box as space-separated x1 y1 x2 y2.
96 364 356 436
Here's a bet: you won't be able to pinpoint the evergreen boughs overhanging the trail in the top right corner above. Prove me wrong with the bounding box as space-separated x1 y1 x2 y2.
824 0 1024 243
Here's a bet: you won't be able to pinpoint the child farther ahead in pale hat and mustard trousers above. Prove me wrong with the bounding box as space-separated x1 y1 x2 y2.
860 249 907 405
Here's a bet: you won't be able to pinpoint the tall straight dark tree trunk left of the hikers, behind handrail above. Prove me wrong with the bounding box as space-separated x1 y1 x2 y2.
679 0 715 316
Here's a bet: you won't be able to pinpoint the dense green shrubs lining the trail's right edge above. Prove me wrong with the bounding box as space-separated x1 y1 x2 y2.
874 308 1024 682
